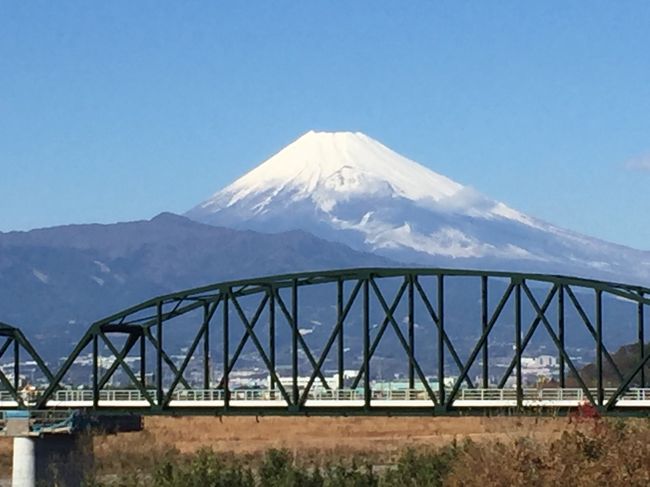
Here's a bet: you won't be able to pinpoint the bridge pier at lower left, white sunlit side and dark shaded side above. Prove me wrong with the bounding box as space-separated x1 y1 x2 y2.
11 434 93 487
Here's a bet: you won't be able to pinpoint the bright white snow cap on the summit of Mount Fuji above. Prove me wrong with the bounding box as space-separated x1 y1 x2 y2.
201 131 470 210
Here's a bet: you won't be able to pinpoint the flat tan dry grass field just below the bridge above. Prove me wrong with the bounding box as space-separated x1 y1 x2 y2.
0 417 628 482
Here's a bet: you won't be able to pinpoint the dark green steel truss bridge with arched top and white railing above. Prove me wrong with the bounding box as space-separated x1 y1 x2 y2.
0 268 650 415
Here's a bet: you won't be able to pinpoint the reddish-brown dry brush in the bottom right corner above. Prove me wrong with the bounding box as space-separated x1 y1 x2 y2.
445 421 650 487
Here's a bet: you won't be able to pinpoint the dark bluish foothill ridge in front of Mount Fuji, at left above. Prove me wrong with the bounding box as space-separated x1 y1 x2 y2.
0 213 395 352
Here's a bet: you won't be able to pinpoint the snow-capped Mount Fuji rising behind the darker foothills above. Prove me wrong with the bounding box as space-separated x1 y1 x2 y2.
186 131 650 284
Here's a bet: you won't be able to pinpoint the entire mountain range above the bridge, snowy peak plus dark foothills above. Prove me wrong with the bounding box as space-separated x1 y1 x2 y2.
0 132 650 357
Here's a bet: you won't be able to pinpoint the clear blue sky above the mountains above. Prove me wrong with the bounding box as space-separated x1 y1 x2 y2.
0 0 650 249
